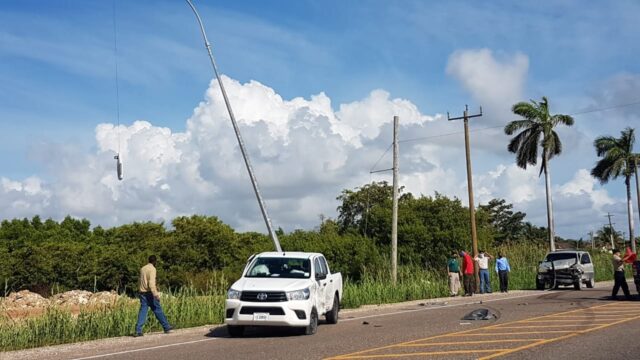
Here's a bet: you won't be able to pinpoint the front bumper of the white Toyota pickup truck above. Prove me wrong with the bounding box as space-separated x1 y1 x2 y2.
224 299 313 327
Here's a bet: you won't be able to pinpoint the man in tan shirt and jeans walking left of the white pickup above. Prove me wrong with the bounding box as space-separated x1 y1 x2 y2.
134 255 171 337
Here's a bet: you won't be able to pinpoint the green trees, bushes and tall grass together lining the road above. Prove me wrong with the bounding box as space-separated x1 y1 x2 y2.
0 182 624 351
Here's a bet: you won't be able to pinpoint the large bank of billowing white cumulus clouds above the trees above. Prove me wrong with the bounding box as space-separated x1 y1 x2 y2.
0 73 632 239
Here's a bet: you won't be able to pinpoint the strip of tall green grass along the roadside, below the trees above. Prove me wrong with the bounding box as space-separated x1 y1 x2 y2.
0 246 630 351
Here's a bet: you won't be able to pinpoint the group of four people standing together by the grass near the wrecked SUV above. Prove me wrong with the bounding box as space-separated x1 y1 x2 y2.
447 250 511 296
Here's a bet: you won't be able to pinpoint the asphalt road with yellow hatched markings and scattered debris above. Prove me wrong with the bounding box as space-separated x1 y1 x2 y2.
5 283 640 360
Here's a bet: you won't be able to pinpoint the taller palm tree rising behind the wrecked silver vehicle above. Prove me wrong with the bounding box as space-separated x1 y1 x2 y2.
504 96 573 251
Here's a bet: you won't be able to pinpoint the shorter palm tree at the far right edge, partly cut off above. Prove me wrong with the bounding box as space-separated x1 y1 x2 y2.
591 127 638 252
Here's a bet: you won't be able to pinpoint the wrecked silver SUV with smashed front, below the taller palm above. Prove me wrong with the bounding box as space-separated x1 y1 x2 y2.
536 250 595 290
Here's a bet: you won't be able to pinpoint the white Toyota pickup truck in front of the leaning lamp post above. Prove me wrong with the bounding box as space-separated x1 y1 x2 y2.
225 252 342 337
